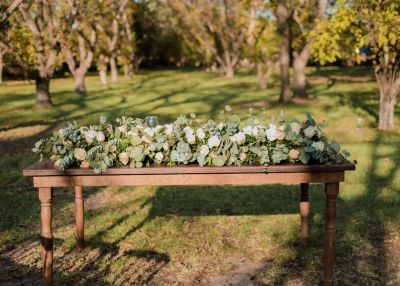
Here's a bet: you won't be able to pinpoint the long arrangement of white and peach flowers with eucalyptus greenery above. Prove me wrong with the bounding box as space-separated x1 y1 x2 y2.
33 106 350 173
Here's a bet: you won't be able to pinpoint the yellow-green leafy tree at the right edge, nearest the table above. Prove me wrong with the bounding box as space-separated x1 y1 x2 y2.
314 0 400 130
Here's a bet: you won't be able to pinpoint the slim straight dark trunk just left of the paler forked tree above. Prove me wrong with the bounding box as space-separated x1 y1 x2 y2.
277 0 290 103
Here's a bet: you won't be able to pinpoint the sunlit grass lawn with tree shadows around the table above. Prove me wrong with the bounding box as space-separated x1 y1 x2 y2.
0 67 400 285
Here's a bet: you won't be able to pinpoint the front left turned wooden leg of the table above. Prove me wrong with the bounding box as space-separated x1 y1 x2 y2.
39 188 53 285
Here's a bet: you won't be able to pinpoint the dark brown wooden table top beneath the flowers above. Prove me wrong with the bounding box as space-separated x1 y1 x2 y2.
22 160 356 177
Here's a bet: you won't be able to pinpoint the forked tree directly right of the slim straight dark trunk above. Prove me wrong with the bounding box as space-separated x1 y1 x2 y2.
291 0 328 97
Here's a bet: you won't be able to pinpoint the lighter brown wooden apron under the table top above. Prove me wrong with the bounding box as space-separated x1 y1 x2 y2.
33 171 344 188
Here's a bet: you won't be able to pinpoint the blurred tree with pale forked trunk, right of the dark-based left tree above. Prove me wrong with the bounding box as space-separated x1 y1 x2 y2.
60 0 98 95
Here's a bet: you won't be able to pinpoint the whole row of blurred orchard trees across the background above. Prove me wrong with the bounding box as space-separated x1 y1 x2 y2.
0 0 400 129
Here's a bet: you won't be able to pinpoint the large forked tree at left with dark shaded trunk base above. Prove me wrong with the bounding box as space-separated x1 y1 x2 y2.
18 0 60 108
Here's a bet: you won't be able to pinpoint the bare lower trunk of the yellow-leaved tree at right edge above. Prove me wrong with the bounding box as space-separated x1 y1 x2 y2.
379 87 396 130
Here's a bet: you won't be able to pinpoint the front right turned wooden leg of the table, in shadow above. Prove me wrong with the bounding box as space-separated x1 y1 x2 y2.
323 182 339 286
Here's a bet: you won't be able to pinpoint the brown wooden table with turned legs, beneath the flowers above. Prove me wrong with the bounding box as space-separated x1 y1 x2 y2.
23 160 355 285
